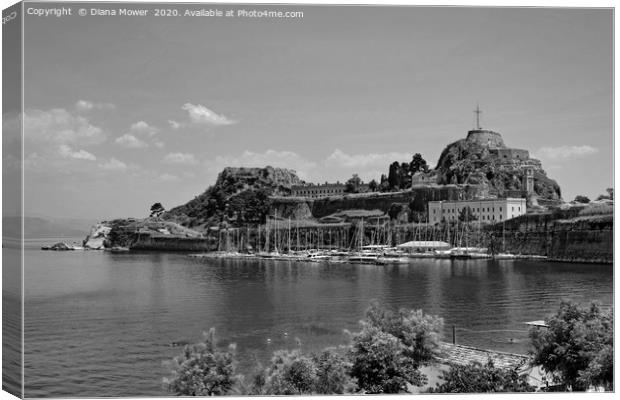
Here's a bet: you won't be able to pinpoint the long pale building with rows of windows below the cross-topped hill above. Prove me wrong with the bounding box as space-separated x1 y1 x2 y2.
428 197 527 224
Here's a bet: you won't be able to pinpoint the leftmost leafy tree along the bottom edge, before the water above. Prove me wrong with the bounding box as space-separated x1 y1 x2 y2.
164 328 239 396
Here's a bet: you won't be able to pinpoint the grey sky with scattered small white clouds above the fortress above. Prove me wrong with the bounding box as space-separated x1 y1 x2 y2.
5 3 613 218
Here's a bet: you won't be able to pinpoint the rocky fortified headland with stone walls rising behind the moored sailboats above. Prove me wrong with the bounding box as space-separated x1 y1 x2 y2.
84 129 613 262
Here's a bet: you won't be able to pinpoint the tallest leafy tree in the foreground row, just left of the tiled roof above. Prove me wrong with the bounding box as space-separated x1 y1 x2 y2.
350 302 443 393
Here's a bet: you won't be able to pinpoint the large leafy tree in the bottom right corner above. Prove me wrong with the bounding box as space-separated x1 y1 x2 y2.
530 301 613 390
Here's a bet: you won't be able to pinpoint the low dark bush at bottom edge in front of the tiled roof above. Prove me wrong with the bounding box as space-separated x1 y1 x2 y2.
429 359 535 393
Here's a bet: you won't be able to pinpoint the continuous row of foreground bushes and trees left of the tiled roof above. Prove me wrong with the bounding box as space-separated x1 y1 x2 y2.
164 303 443 396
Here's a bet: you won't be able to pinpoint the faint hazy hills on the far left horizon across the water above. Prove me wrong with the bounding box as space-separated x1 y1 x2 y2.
2 216 97 239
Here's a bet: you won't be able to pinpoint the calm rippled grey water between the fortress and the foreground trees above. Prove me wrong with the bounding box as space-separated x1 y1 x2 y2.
25 245 613 397
